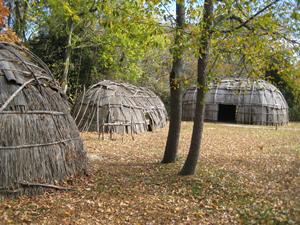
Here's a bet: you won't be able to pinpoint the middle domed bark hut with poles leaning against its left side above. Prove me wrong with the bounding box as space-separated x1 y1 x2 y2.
73 80 167 133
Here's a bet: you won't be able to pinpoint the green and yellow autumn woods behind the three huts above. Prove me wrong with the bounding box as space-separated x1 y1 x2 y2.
1 0 299 119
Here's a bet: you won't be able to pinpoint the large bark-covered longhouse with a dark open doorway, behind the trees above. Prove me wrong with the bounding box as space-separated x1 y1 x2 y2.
182 79 289 125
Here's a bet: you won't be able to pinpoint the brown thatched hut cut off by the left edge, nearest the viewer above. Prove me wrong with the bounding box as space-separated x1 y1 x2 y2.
0 42 88 200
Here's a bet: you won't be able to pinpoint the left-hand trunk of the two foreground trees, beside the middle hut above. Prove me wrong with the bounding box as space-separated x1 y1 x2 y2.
162 0 185 163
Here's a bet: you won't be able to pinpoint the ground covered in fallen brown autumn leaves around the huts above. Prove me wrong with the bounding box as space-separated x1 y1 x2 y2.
0 122 300 224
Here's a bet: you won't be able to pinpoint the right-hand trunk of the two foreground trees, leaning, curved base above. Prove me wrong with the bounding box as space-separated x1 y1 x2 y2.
179 0 213 175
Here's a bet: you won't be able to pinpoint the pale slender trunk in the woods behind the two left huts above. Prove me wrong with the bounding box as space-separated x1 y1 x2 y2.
61 18 74 94
